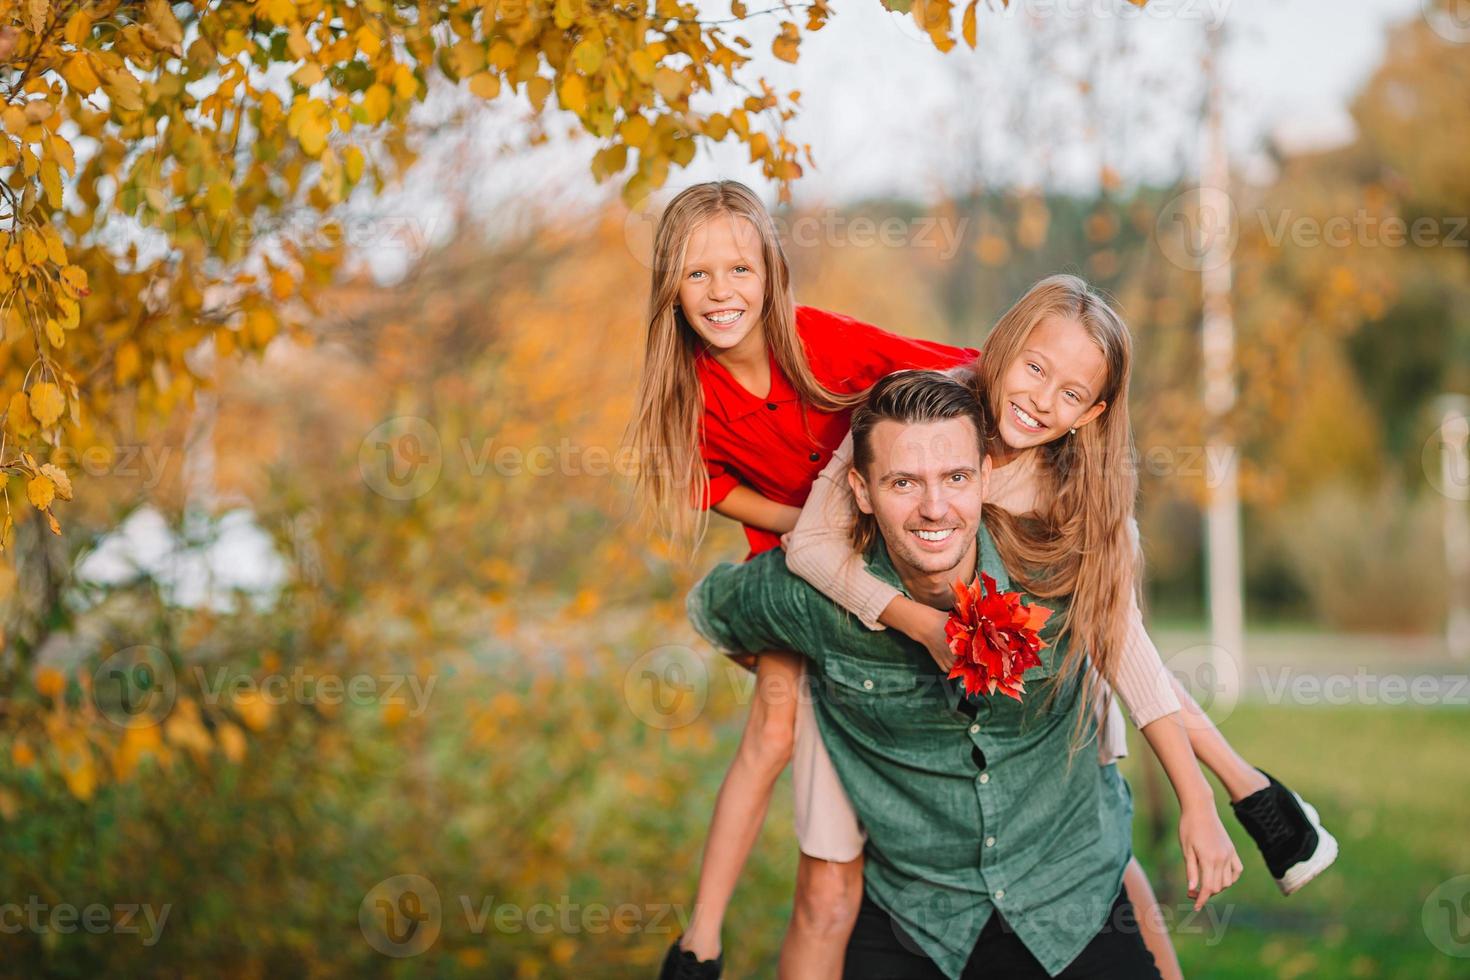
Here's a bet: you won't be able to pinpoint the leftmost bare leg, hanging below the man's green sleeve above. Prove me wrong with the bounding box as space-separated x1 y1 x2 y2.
679 651 803 959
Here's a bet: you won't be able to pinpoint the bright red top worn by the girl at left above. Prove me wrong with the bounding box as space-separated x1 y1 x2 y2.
694 306 980 561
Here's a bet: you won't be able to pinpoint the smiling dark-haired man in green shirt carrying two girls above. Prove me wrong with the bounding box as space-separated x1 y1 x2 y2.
688 372 1158 980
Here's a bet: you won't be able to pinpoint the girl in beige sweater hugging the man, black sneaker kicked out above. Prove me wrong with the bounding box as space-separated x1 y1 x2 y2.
782 276 1336 977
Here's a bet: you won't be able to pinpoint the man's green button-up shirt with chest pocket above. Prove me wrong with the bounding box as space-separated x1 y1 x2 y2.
688 526 1133 979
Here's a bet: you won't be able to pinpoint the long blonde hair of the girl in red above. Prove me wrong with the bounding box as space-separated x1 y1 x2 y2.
631 181 861 552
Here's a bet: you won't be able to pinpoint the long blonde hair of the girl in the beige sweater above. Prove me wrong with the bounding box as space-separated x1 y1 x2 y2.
975 275 1139 731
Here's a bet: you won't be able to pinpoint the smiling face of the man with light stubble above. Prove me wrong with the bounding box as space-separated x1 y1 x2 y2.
848 419 991 574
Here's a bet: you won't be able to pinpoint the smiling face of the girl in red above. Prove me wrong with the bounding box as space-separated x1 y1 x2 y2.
679 215 766 354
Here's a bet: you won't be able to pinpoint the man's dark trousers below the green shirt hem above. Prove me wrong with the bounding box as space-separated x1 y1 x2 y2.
842 890 1160 980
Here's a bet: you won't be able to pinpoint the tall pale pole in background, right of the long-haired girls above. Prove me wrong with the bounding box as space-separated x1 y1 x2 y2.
1200 25 1245 704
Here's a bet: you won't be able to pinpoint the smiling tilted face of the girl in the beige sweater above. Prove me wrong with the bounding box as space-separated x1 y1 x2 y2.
995 314 1107 450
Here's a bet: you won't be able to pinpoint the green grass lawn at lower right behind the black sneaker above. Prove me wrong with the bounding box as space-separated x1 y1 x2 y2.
1125 705 1470 979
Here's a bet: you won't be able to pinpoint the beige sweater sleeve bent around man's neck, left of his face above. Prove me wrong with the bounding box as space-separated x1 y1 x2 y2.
785 432 900 630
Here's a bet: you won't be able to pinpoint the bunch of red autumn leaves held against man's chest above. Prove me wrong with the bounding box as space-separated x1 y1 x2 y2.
944 572 1051 701
